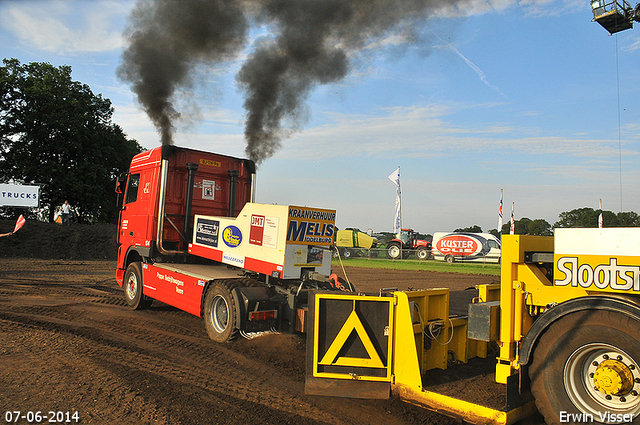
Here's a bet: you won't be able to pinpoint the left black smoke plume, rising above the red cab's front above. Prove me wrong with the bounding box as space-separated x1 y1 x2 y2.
117 0 249 144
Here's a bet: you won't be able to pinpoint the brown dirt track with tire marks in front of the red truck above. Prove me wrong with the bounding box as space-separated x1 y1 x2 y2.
0 263 470 425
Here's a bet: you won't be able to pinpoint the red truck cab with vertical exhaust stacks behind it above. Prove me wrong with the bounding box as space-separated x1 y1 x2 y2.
116 146 255 284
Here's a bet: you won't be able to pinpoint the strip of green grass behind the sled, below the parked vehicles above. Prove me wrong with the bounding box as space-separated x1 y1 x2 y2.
331 258 500 276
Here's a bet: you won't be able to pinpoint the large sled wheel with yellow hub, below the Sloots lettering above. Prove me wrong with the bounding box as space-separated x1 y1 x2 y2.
529 310 640 424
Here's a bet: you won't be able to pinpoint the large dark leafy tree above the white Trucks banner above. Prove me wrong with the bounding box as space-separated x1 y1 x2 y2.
0 59 142 222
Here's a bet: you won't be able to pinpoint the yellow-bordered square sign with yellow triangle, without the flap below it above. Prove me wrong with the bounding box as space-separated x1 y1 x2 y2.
313 294 393 381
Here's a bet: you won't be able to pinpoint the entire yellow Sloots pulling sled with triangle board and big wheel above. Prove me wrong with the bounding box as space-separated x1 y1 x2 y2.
306 228 640 424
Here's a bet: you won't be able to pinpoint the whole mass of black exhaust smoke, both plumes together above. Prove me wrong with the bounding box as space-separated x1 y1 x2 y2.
118 0 452 163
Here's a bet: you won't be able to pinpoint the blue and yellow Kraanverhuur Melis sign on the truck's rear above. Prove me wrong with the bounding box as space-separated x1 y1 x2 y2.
287 207 336 246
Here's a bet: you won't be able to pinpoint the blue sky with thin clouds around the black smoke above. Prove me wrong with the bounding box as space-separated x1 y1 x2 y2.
0 0 640 233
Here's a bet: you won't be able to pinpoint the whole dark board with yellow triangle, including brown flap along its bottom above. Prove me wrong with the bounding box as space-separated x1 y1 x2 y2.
305 292 394 399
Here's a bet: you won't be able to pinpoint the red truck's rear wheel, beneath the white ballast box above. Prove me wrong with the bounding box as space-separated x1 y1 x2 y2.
202 281 238 342
